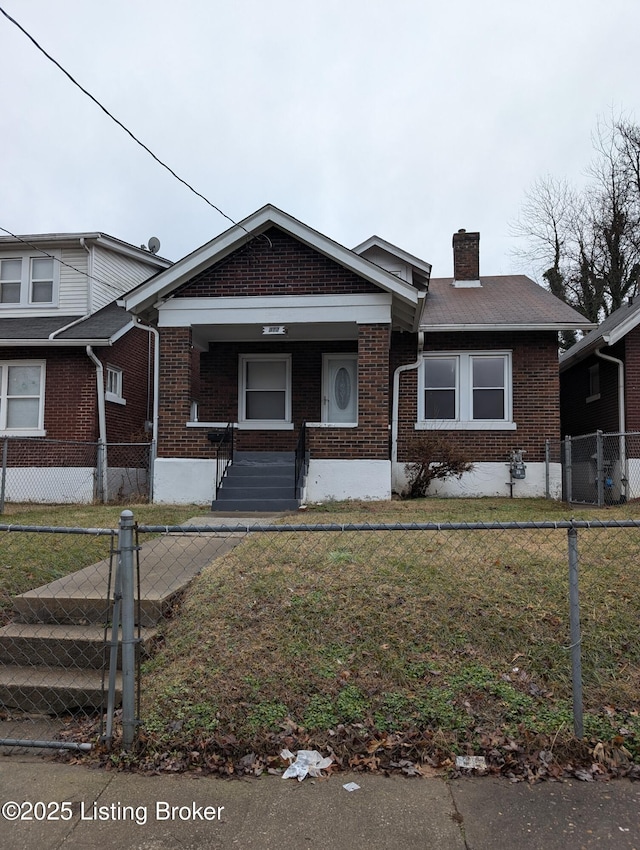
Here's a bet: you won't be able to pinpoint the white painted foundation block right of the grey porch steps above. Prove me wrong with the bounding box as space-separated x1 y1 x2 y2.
305 458 391 502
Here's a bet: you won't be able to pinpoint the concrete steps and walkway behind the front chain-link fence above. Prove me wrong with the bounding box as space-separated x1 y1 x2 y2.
0 533 243 714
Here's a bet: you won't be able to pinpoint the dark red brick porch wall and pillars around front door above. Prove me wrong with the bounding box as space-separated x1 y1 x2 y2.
158 325 389 458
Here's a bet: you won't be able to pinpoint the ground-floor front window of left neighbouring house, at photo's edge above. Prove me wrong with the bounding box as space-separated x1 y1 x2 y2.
0 360 44 434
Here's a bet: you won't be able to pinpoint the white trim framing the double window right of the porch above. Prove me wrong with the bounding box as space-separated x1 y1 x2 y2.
415 351 518 431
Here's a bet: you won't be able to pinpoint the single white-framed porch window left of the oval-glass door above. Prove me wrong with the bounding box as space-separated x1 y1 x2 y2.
239 354 291 427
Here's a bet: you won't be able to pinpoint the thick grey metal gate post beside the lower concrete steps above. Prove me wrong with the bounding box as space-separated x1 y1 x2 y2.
118 511 137 750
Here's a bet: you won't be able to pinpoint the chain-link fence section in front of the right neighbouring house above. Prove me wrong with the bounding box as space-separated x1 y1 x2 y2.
562 431 640 507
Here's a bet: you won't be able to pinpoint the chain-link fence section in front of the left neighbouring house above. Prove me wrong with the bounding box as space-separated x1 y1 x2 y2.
0 437 152 513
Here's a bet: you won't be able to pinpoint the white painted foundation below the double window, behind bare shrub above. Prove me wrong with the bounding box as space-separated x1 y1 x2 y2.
393 463 562 499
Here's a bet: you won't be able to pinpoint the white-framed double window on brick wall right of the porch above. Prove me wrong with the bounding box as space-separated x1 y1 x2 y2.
418 351 515 430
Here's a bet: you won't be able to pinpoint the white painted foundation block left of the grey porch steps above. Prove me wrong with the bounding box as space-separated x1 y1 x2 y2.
153 457 216 505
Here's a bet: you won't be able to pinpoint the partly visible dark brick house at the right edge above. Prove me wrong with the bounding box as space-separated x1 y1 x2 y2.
560 299 640 501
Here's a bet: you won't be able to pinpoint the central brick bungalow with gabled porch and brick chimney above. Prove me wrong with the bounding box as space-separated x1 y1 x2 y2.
124 205 591 507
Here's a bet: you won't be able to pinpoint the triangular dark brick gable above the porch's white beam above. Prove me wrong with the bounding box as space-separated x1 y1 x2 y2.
174 227 380 298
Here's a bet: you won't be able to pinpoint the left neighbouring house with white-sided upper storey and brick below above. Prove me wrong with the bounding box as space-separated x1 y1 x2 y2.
0 233 170 502
